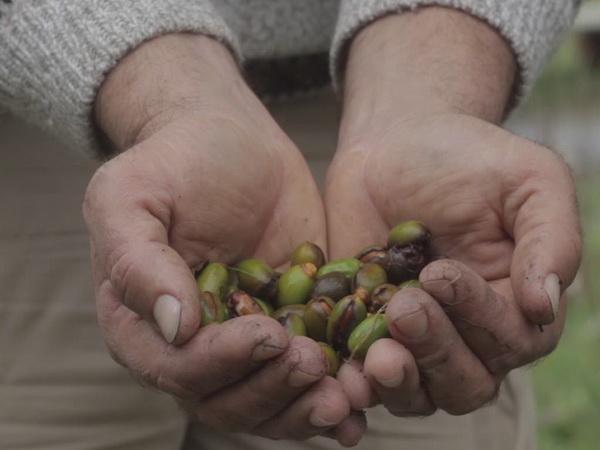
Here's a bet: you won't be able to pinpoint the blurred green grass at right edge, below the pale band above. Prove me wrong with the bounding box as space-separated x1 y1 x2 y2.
533 177 600 450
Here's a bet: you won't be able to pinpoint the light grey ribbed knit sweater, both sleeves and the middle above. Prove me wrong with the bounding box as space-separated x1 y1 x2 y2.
0 0 580 153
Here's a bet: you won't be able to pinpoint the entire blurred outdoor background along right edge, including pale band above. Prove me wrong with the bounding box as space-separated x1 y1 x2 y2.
507 1 600 450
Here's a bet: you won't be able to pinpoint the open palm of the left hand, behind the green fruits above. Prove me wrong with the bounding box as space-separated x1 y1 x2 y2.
86 108 324 278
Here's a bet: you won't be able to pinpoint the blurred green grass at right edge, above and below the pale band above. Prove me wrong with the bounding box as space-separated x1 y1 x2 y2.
519 27 600 450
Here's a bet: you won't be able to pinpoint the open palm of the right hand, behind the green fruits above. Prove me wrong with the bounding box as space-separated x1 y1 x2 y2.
326 116 524 280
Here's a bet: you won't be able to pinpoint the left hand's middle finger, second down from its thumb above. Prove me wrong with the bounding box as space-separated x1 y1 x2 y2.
196 337 327 432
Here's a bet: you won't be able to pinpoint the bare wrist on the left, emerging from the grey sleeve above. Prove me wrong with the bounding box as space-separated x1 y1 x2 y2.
94 34 245 150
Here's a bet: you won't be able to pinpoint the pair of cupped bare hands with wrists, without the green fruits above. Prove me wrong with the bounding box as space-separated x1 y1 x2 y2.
84 8 581 445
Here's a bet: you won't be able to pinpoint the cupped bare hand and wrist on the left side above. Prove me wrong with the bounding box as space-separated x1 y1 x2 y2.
84 35 364 445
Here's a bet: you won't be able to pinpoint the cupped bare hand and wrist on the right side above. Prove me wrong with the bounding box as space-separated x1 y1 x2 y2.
325 8 581 415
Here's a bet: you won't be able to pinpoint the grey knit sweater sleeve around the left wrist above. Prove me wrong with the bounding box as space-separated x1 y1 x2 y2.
0 0 239 154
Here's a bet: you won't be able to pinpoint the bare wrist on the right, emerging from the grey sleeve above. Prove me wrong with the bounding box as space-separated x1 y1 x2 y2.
341 7 516 146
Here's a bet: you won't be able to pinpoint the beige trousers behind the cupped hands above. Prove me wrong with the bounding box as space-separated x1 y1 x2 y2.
0 90 535 450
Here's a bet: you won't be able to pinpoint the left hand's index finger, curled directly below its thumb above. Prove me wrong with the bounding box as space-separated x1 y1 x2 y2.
98 282 288 401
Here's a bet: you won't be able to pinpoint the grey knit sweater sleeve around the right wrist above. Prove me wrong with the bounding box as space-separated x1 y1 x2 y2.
330 0 581 104
